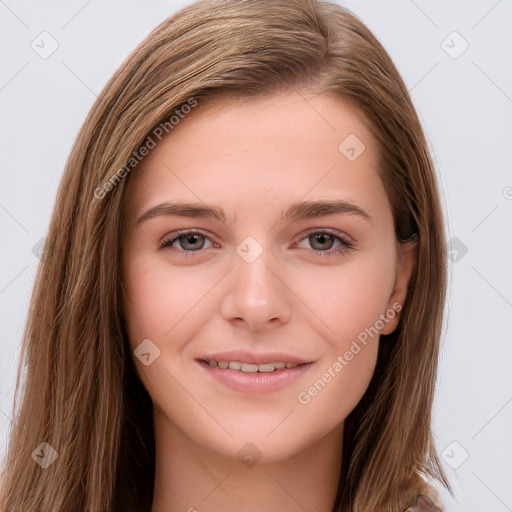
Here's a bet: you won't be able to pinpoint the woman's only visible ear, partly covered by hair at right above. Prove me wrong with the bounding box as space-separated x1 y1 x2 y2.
381 241 417 334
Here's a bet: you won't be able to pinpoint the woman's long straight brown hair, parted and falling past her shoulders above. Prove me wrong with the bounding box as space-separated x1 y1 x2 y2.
0 0 451 512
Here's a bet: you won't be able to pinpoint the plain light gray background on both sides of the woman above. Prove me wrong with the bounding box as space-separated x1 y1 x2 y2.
0 0 512 512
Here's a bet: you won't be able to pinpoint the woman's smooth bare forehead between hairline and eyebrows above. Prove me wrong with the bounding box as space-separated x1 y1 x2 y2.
122 91 388 226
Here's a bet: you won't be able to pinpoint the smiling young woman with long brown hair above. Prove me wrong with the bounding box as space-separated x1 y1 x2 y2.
0 0 450 512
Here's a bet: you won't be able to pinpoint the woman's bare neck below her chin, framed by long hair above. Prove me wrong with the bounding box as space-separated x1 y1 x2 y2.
151 415 343 512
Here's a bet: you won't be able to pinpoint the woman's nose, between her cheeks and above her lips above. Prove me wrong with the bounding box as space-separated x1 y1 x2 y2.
221 247 293 331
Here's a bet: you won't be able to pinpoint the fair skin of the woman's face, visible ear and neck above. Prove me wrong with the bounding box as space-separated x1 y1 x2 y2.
122 92 414 512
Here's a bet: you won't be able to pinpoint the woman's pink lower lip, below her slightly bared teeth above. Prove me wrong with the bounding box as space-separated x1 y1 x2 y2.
199 361 312 394
